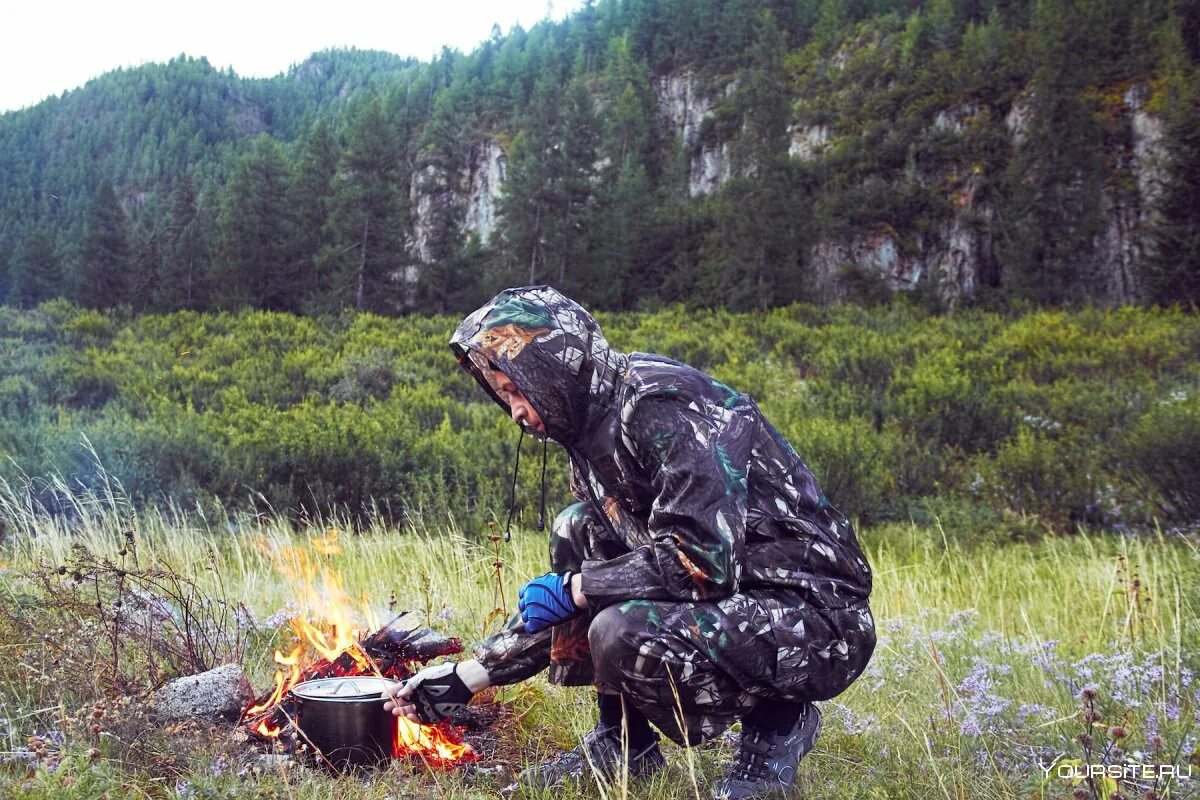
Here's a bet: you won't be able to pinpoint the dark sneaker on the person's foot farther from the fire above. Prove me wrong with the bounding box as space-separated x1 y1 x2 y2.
713 703 821 800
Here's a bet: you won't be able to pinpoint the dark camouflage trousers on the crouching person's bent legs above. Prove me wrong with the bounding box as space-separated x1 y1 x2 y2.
550 503 875 744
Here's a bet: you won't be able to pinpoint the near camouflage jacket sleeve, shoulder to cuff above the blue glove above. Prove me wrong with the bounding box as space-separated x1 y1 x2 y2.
582 396 754 608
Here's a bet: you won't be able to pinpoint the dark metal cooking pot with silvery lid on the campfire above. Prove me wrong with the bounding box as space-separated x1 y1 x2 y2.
292 675 397 770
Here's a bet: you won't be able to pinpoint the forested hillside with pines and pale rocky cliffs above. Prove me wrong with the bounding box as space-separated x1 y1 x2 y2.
0 0 1200 313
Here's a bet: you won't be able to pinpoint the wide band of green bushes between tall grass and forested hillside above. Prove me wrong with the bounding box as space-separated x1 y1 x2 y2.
0 301 1200 527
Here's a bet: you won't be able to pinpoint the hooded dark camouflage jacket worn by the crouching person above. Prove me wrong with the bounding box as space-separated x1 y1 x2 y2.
450 287 871 682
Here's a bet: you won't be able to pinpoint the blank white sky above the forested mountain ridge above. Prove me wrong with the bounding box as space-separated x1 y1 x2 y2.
0 0 580 112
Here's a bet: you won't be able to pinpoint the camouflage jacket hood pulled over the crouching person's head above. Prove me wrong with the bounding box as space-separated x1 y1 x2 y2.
450 285 629 445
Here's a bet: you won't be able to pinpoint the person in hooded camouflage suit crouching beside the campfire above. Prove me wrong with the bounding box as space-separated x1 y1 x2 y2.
379 287 875 798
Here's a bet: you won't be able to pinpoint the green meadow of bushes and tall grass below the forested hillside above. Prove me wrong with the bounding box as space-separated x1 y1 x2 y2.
0 302 1200 800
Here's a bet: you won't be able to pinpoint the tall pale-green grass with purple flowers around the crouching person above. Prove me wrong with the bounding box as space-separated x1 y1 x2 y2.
0 487 1200 800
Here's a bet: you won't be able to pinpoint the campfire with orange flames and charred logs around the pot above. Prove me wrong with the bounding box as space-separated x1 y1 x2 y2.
242 530 475 769
